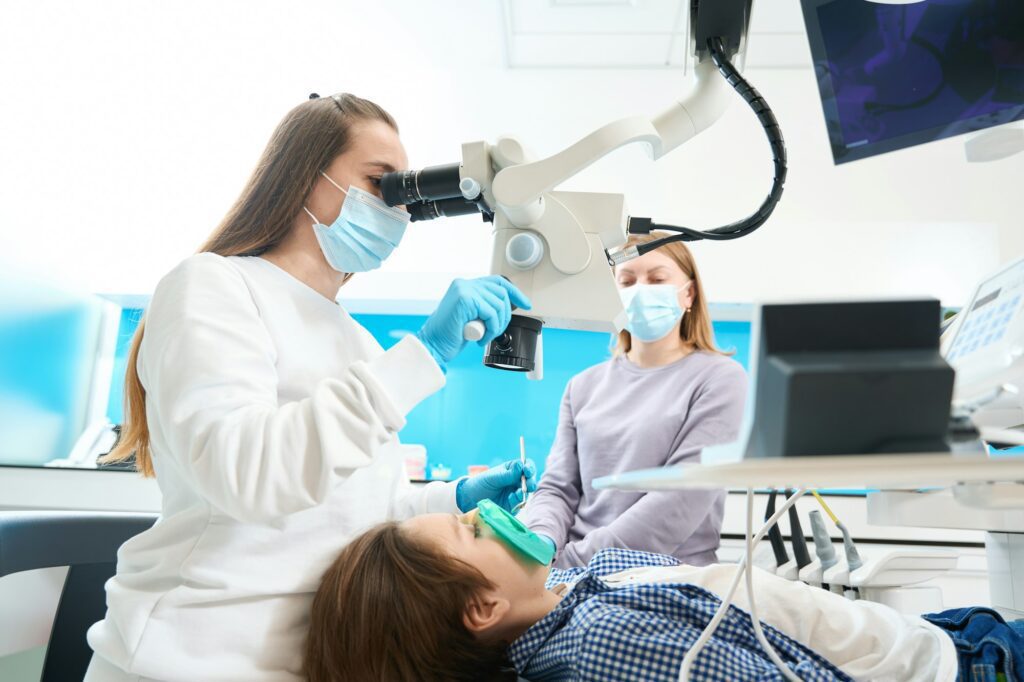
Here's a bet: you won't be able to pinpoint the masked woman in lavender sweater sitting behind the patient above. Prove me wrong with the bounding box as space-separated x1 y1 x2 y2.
520 237 746 567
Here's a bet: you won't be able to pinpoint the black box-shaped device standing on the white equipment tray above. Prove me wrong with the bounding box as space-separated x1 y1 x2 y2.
745 300 953 457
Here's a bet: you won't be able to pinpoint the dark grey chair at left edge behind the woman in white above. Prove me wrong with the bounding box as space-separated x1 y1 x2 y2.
0 511 157 682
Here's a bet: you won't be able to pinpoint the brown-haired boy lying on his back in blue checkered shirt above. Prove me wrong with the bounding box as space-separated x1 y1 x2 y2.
304 503 1024 682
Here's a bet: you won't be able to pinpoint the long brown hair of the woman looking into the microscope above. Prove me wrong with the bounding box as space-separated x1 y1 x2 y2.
99 94 398 476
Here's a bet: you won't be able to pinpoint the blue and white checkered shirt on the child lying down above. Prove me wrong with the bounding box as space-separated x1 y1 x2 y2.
508 548 850 682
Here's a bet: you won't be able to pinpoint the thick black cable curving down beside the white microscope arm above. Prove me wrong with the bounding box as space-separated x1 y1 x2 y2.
629 38 786 256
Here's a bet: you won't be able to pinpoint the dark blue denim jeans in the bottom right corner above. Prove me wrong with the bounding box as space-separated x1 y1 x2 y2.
924 606 1024 682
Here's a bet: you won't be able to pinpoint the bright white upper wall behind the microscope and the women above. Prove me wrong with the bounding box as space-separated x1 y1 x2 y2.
0 0 1024 303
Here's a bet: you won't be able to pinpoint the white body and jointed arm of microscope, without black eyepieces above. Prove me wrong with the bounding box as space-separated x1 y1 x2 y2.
460 58 733 376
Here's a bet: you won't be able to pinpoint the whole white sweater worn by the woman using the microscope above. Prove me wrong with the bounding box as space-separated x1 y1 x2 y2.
86 253 457 682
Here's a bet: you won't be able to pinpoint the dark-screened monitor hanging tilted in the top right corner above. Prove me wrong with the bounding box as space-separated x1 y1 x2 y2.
801 0 1024 164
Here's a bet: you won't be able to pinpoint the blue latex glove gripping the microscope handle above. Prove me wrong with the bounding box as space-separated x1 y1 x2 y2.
416 275 530 370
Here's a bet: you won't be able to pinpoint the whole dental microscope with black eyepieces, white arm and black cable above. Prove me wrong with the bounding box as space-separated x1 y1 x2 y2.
381 0 786 379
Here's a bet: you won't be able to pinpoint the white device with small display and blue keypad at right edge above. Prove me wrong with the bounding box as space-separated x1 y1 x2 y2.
942 258 1024 426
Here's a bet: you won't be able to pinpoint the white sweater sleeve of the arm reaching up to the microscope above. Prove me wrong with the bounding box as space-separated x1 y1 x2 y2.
137 254 444 522
